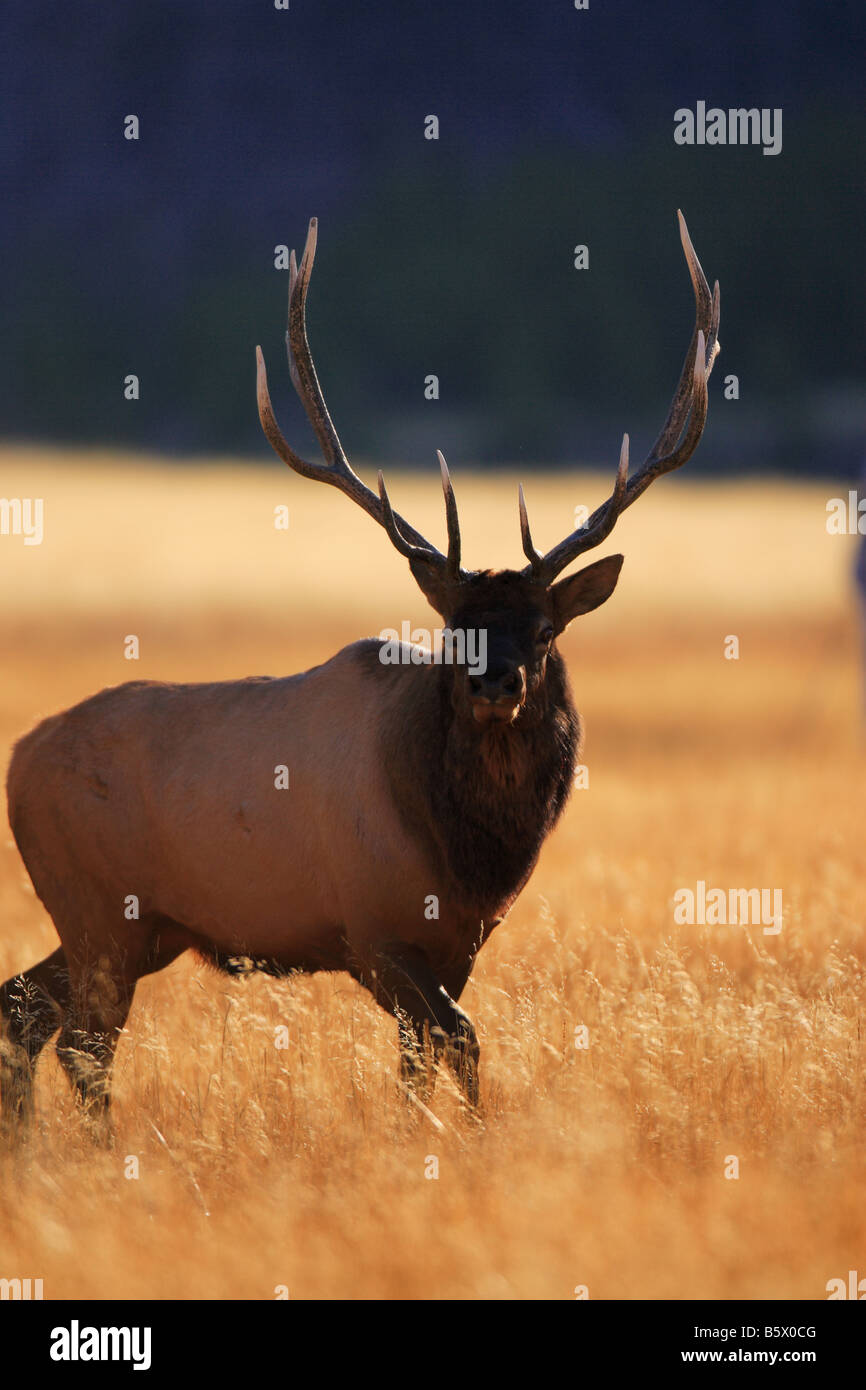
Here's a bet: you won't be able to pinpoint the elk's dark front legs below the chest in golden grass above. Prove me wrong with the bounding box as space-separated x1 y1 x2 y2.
361 947 480 1106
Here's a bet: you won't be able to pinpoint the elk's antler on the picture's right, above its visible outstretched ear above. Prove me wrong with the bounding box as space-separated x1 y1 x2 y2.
520 210 720 584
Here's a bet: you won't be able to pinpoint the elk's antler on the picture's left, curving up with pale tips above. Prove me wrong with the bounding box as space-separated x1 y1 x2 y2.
256 217 460 581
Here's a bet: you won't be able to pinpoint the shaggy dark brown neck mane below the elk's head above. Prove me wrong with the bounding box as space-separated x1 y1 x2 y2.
364 641 581 919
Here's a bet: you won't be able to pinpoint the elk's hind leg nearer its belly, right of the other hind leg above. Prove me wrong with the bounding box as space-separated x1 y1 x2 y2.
57 954 139 1144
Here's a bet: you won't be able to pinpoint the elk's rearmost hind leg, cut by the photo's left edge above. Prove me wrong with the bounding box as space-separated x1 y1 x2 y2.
0 947 70 1134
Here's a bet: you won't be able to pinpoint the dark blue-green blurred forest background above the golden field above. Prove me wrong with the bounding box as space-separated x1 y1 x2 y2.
0 0 866 477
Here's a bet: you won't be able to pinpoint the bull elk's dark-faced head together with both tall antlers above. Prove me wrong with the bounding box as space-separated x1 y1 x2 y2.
256 213 719 731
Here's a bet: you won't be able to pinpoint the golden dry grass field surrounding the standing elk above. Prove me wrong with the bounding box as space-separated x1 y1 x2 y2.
0 450 866 1300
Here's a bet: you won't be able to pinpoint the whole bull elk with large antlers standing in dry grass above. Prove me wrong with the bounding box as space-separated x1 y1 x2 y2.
0 215 719 1126
